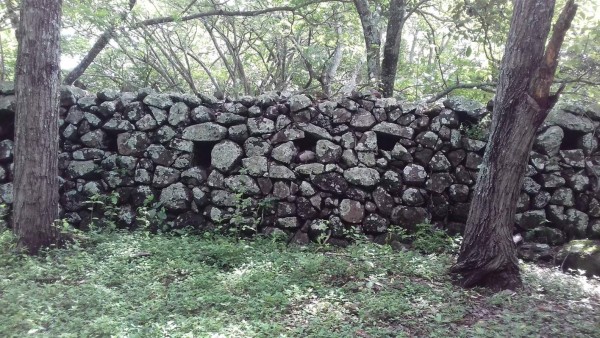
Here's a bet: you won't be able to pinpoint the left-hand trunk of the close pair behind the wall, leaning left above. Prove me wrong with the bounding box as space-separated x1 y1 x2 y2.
354 0 381 88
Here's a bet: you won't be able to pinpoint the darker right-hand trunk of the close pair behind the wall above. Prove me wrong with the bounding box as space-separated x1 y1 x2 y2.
381 0 406 97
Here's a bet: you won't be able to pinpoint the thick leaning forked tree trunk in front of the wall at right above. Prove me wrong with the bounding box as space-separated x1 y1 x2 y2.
451 0 577 290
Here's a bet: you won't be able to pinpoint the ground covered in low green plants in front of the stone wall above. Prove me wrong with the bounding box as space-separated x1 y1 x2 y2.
0 231 600 337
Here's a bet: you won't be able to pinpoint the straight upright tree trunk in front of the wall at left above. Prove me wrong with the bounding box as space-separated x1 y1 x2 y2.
13 0 62 254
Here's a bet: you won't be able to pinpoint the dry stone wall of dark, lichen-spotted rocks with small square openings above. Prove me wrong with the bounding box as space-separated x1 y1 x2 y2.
0 83 600 244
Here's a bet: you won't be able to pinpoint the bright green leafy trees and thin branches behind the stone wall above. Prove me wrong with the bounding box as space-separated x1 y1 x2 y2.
0 0 600 102
